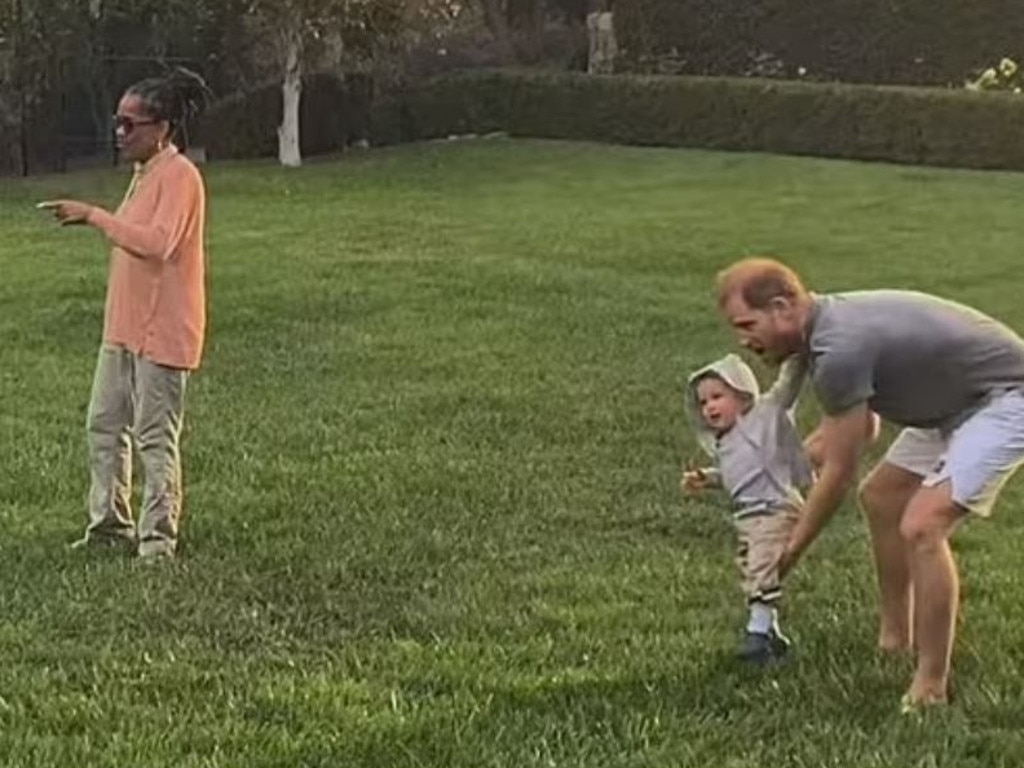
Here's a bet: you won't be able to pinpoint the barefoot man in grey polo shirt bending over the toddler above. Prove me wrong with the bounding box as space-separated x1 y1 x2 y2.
718 259 1024 708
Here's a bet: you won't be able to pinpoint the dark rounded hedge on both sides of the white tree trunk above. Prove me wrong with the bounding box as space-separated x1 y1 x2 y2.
193 75 370 160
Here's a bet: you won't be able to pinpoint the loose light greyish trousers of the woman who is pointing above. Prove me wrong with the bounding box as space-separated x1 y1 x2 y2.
86 344 188 556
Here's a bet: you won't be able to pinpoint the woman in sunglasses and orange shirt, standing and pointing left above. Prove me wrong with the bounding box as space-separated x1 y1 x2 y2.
40 69 210 562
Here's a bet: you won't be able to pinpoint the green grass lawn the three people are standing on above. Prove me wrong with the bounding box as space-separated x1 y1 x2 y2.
0 140 1024 768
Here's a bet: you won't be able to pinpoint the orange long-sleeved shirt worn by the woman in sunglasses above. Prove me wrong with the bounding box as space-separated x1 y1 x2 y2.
88 144 206 370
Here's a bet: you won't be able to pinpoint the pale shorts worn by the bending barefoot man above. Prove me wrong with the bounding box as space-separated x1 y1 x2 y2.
885 390 1024 516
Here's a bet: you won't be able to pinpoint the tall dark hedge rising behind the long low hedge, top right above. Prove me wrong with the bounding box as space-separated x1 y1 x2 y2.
615 0 1024 86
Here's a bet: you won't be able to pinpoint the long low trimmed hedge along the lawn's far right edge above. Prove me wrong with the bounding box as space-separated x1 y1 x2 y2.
371 71 1024 170
